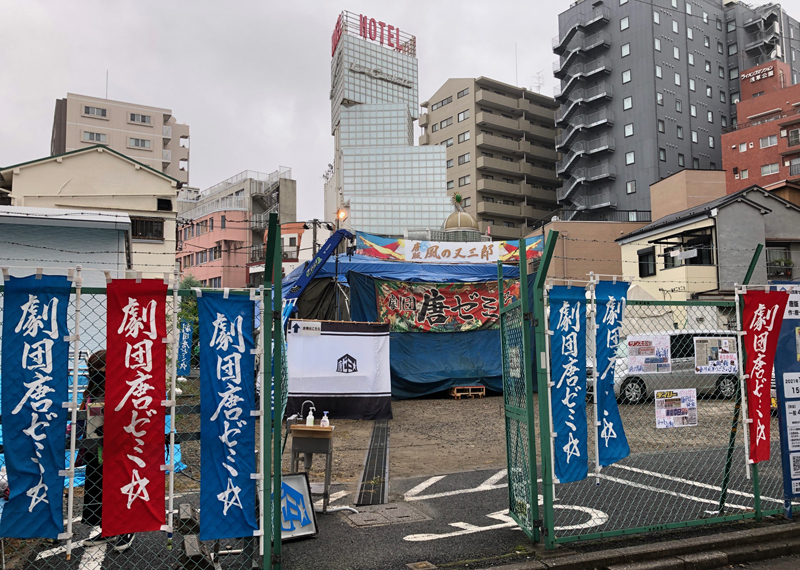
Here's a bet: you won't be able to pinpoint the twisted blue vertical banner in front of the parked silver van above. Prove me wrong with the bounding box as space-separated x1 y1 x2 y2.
594 281 631 467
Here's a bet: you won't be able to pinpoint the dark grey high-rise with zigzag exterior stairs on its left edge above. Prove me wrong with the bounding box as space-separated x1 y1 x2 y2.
553 0 800 221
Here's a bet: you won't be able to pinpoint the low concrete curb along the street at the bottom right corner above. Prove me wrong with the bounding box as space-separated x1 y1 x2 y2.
484 524 800 570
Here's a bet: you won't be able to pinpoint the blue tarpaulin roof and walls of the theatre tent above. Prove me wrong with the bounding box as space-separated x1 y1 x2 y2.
283 255 533 398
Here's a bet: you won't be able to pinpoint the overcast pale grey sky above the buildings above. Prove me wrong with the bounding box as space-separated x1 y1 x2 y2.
0 0 569 220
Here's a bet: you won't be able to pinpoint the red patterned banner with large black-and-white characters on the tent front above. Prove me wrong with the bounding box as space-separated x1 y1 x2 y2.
375 279 519 332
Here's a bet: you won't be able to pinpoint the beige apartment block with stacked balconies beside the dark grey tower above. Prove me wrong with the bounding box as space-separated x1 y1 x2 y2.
419 77 561 239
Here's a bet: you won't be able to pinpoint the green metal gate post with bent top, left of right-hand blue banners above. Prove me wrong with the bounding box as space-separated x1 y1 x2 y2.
531 230 558 550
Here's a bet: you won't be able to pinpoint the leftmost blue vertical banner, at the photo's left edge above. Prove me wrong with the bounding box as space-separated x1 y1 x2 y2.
0 275 70 538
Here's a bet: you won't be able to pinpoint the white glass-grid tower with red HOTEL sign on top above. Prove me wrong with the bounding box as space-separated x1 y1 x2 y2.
325 12 452 236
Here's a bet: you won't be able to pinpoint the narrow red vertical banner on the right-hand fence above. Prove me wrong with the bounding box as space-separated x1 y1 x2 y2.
742 291 789 463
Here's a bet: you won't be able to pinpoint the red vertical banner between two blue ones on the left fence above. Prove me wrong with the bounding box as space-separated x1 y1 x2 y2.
102 279 167 536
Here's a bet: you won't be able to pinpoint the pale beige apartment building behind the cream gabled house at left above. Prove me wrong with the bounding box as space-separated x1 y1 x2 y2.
50 93 189 184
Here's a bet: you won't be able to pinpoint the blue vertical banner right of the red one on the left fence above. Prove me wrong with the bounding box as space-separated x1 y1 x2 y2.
197 293 258 540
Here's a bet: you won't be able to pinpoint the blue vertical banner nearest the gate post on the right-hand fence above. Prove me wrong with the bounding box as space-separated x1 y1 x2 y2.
550 286 589 483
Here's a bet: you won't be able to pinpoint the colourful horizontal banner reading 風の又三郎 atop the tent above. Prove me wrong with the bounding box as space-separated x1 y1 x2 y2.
356 232 544 263
